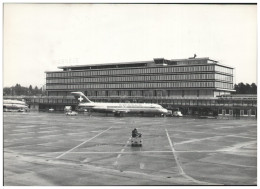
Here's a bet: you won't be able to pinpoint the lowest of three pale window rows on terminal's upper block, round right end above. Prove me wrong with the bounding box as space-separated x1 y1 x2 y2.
46 82 233 90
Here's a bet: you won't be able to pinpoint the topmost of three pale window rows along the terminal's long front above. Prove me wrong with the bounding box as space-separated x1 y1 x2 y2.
47 65 218 78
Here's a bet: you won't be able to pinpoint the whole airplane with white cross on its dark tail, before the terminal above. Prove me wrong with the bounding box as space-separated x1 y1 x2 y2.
71 92 168 116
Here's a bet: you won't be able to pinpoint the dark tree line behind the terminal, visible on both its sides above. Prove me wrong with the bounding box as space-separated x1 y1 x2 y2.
3 82 257 96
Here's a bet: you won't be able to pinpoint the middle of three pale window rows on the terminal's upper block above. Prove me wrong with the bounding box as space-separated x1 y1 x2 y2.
46 74 229 84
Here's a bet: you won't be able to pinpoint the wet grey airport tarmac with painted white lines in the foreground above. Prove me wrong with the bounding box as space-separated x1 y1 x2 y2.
3 112 257 186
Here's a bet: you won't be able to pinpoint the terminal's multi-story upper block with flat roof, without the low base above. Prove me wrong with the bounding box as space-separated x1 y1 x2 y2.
46 58 234 98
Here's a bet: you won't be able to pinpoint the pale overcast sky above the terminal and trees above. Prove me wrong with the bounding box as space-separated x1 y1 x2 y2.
3 4 257 87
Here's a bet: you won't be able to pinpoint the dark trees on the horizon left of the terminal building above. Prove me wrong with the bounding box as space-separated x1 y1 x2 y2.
3 84 46 96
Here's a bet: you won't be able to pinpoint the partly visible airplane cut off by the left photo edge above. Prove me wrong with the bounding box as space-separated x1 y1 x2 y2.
3 100 29 112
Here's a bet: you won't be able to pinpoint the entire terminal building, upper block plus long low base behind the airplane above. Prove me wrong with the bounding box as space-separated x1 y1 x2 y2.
6 58 257 118
